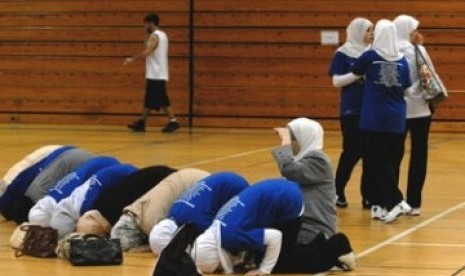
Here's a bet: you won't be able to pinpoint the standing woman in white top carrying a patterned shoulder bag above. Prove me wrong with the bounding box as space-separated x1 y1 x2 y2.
394 15 434 216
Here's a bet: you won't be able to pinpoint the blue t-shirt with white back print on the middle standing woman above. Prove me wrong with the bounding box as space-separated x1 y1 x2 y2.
352 50 412 133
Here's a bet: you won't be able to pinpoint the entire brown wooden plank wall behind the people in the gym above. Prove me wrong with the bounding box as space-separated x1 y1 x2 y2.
0 0 465 127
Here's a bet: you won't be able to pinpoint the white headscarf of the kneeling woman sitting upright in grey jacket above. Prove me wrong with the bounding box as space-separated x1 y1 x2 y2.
287 118 324 160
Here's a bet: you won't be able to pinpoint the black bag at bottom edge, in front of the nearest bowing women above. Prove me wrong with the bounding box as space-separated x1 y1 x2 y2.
153 224 202 276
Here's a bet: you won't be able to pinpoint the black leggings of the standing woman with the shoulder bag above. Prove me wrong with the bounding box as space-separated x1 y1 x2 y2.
404 116 431 208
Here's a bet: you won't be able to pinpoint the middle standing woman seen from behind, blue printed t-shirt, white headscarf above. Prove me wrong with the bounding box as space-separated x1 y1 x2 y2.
349 19 412 222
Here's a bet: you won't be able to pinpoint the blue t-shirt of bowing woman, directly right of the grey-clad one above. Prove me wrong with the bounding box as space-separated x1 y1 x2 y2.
48 156 119 203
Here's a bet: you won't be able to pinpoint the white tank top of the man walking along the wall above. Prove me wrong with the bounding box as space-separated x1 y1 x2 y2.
145 30 169 81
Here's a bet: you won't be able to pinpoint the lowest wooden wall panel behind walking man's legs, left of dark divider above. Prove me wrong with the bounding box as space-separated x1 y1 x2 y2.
0 86 188 116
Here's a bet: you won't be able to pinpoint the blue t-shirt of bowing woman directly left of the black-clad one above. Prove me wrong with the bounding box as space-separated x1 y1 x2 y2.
79 164 137 215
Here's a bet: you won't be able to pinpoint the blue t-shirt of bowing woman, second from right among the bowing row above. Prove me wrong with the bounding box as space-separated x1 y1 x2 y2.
168 172 249 231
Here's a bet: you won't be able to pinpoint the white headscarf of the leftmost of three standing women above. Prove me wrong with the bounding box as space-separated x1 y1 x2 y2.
337 17 373 58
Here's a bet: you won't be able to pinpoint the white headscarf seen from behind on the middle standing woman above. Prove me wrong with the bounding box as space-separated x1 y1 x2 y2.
373 19 402 61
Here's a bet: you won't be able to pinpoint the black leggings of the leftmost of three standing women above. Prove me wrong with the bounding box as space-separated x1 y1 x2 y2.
336 116 369 199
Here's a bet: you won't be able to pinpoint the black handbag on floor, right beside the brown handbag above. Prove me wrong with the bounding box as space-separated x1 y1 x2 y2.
69 235 123 266
